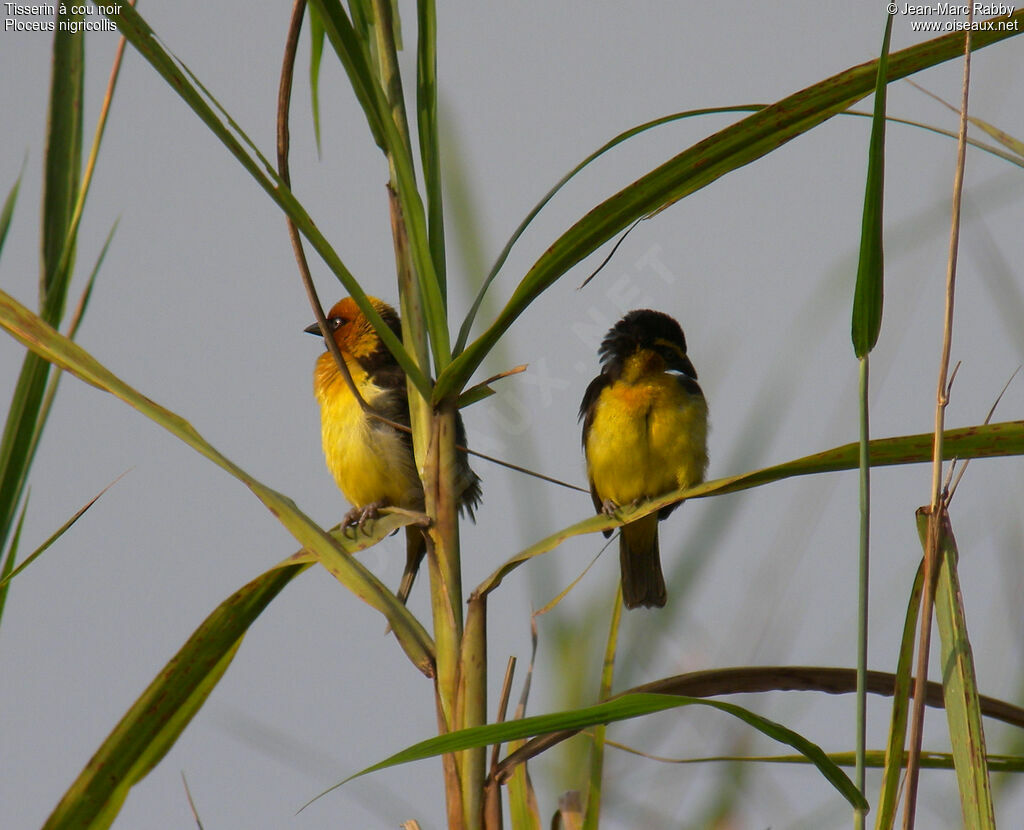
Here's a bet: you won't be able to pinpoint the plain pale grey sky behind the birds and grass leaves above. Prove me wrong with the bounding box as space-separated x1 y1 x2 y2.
0 2 1024 830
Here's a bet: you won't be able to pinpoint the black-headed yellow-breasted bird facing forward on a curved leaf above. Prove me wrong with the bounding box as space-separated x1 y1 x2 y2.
580 309 708 608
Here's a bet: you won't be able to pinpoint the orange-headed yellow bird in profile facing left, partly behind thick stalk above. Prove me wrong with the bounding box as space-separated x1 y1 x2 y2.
305 297 480 603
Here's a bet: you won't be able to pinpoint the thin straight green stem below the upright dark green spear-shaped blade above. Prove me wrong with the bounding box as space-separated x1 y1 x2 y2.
853 354 871 830
